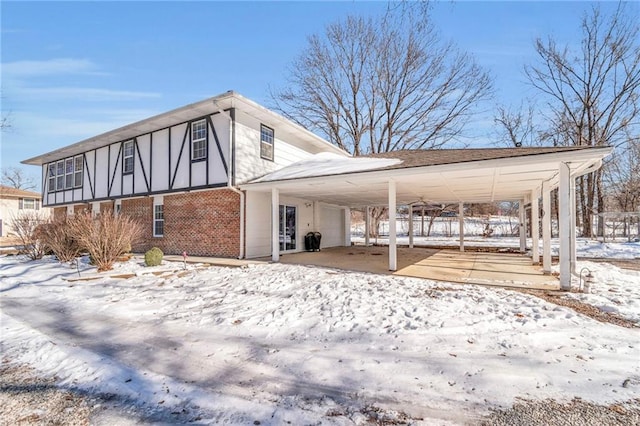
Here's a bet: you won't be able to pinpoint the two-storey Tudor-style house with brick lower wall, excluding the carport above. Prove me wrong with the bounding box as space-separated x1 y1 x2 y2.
23 91 349 258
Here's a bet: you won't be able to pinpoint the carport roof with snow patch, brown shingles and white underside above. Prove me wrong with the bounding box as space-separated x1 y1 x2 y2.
241 147 612 207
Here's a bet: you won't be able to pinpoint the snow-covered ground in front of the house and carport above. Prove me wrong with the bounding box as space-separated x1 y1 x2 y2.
0 243 640 425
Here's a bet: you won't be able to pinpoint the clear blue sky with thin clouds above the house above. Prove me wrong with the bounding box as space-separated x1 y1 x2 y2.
0 1 640 188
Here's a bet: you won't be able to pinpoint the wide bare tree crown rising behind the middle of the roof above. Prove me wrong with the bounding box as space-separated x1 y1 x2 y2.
272 4 492 155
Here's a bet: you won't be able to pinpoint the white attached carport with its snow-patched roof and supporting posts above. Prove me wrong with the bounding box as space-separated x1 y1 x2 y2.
241 147 612 290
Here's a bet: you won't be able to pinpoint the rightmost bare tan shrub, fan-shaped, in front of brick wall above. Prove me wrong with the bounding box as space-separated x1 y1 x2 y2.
69 211 142 271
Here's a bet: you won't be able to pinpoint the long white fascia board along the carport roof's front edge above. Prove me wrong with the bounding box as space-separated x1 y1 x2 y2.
240 147 613 191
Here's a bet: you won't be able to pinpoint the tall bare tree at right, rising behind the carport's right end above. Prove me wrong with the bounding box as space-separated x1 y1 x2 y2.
525 3 640 236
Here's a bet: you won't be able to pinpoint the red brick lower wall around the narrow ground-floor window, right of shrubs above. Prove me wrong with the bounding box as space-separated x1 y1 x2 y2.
122 189 240 257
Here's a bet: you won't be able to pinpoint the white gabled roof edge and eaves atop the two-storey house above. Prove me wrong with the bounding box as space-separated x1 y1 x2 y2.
22 90 348 166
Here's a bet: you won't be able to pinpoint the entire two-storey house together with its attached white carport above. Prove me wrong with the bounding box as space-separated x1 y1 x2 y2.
23 91 612 289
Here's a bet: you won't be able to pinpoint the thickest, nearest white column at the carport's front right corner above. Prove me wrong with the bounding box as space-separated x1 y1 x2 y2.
558 163 573 291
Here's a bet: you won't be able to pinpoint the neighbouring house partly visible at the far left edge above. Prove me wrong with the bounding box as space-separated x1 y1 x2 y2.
0 185 50 237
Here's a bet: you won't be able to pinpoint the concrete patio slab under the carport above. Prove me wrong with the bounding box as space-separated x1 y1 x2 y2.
280 246 560 290
